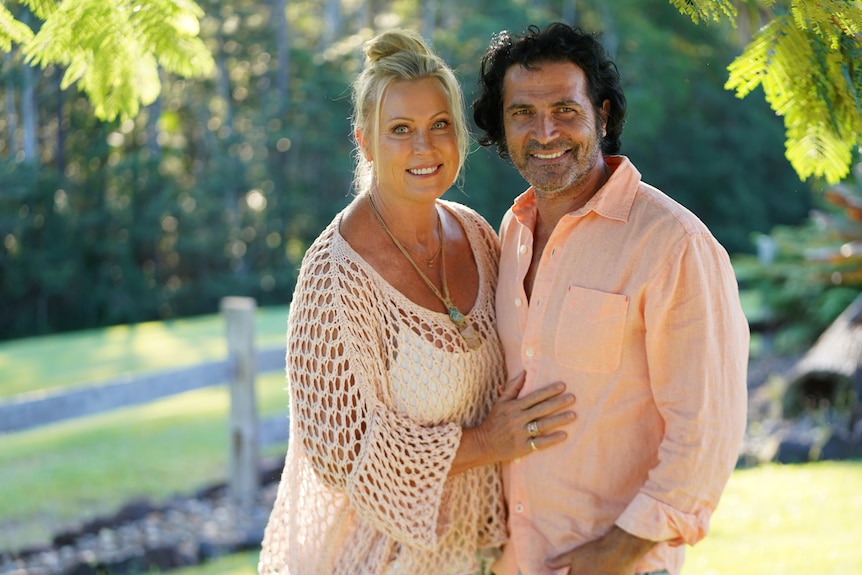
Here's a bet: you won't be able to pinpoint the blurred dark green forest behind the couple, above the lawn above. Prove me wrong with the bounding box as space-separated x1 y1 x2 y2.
0 0 856 339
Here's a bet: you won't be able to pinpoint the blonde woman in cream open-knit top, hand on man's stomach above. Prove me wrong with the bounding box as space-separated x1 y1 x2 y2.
259 31 574 575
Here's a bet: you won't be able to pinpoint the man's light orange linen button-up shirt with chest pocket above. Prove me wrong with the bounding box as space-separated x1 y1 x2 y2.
494 156 749 575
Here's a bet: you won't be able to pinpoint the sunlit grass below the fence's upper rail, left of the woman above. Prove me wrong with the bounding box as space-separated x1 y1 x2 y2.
0 372 287 550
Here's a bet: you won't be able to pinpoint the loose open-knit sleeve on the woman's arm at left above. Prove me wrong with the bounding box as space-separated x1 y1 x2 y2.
287 241 461 548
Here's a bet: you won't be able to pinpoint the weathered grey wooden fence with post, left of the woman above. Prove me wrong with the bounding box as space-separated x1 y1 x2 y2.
0 297 288 510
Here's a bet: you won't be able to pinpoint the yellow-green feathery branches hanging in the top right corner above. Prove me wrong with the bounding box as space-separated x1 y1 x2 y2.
671 0 862 184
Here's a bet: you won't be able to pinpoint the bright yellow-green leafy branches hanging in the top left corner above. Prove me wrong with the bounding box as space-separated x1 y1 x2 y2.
0 0 214 120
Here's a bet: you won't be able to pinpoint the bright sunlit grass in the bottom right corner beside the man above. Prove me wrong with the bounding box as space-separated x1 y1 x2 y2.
683 462 862 575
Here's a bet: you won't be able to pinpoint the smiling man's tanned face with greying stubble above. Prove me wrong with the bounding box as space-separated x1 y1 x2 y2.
503 62 609 196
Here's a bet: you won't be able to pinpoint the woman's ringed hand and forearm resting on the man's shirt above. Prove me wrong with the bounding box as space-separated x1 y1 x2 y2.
450 374 575 475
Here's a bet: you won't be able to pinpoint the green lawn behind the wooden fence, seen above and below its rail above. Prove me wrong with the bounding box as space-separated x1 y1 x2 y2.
0 308 294 551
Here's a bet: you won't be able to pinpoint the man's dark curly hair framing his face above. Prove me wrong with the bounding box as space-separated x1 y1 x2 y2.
473 22 626 158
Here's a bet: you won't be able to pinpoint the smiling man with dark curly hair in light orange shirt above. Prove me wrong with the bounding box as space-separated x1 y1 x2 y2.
473 24 749 575
